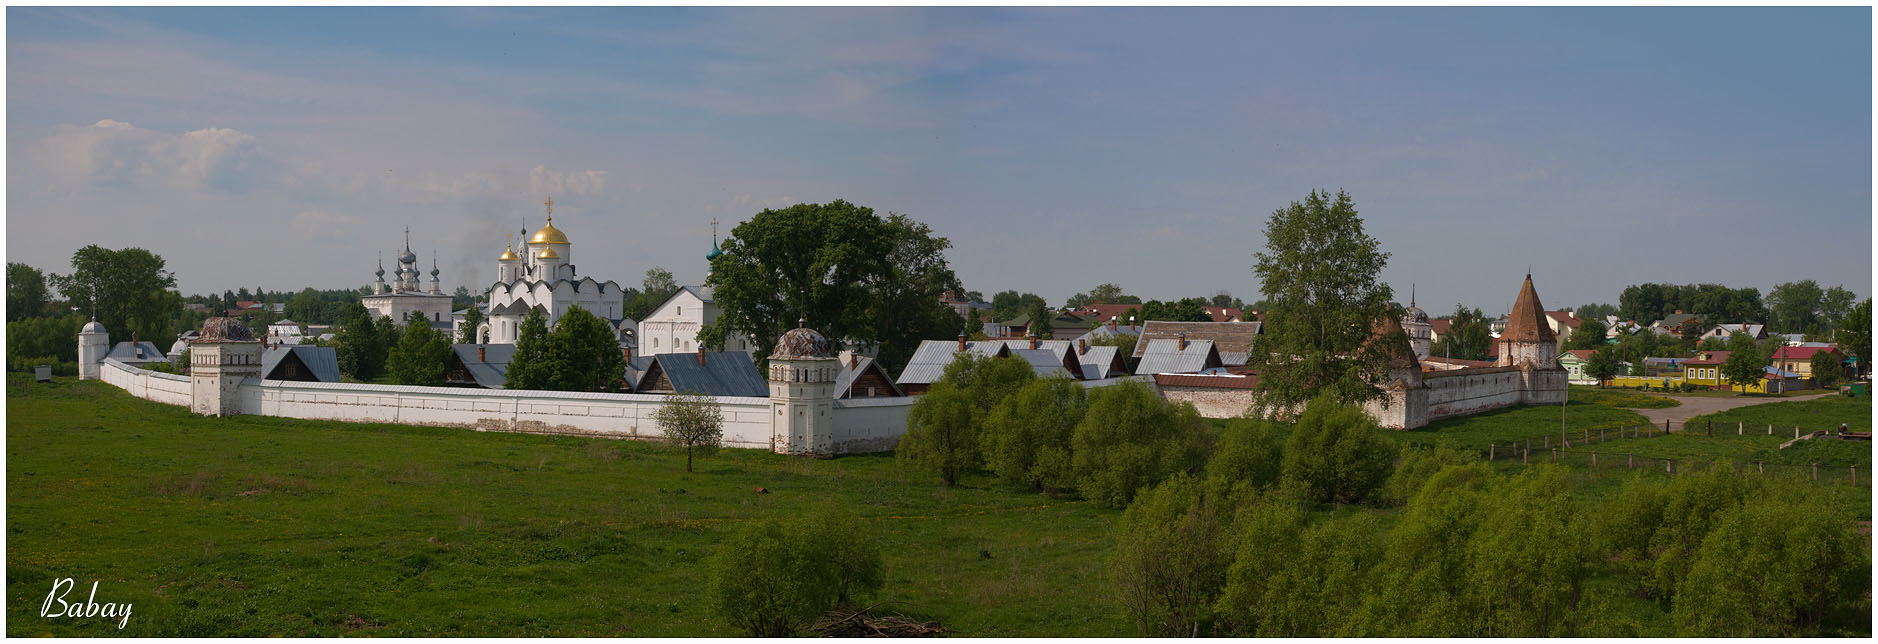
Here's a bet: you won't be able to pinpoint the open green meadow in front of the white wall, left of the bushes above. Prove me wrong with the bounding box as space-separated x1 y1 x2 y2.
6 379 1134 636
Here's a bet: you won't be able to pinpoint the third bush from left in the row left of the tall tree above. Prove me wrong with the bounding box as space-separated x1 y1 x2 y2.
1070 381 1211 507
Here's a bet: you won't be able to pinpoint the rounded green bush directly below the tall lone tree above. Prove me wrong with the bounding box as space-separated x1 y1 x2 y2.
1283 396 1395 503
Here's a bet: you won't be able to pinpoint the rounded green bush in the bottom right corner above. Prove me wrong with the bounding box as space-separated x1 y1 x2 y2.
1673 494 1870 636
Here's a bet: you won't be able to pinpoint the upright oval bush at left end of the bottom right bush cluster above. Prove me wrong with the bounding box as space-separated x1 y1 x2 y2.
1110 473 1232 636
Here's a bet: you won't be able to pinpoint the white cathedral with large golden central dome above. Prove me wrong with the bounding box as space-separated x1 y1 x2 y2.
477 199 635 344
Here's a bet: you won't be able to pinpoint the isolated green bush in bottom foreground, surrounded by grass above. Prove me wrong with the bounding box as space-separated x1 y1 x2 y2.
710 513 883 636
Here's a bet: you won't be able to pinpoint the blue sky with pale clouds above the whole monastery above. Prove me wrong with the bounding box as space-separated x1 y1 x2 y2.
6 8 1872 315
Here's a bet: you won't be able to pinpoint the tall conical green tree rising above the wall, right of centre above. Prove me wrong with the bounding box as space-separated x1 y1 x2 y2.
1247 190 1407 409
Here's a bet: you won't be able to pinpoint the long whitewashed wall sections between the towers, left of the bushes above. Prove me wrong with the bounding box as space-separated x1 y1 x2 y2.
100 360 916 452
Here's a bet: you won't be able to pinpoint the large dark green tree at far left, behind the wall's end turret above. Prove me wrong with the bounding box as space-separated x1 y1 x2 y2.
53 246 182 340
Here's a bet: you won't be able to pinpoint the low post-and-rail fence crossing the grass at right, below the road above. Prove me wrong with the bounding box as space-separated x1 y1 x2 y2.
1485 421 1872 486
